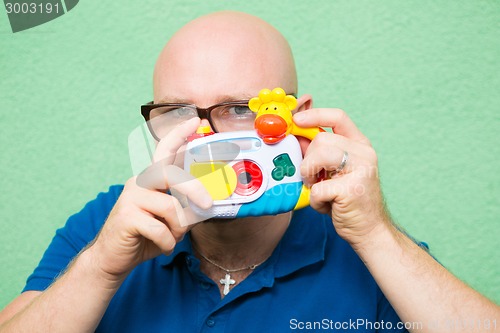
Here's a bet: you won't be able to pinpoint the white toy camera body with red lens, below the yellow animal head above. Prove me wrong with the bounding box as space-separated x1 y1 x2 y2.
184 131 309 218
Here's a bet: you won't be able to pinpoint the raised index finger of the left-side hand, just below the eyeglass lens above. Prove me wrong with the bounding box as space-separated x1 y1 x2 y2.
153 117 200 164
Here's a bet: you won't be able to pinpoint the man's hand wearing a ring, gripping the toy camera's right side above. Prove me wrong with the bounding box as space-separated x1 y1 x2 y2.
294 109 390 249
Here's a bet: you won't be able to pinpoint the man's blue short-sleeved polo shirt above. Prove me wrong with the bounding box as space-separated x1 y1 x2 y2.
24 186 407 333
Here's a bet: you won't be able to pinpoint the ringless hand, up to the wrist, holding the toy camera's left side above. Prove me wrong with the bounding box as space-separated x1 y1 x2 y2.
87 118 212 282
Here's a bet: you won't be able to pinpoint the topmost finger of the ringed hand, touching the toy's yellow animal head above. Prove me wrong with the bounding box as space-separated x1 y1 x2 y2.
293 109 370 144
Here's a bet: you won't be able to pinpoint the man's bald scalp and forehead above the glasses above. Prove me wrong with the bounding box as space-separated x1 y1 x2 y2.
154 11 297 106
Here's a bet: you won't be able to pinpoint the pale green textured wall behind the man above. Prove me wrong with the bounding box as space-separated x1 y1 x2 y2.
0 0 500 308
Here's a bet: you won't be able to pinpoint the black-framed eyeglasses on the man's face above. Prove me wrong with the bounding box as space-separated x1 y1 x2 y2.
141 100 256 141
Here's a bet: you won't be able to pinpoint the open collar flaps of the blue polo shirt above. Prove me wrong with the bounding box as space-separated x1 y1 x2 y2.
157 207 331 277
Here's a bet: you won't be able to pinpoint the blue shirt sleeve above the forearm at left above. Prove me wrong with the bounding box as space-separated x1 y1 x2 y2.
22 185 123 292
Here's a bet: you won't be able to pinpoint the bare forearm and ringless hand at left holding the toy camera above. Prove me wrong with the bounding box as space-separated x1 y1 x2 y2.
0 118 212 332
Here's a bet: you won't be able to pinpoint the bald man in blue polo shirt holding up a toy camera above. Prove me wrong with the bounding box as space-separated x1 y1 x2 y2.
0 12 498 332
